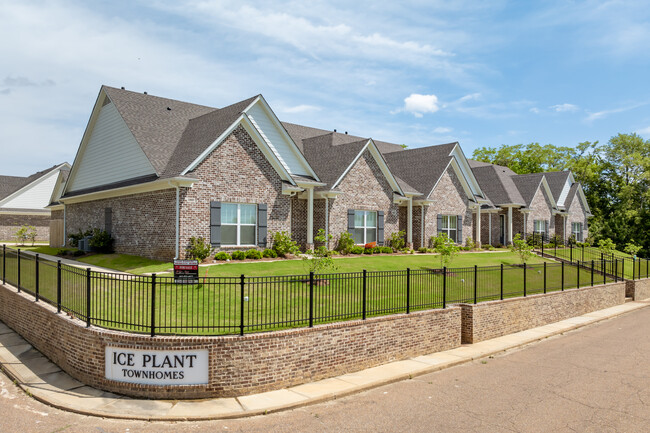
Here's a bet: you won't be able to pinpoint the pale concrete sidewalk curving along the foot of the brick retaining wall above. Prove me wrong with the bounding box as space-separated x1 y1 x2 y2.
0 299 650 421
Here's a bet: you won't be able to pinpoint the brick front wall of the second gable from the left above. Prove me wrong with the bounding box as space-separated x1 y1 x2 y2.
324 150 400 248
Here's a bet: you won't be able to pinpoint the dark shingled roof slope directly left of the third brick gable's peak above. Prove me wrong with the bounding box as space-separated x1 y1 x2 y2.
384 143 458 196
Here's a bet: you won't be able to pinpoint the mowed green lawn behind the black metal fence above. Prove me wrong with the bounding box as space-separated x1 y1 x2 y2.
0 246 610 335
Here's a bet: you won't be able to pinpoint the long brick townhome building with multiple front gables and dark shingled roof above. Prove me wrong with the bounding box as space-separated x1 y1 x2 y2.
58 86 586 259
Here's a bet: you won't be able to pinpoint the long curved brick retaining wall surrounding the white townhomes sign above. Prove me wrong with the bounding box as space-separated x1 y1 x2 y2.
0 285 461 399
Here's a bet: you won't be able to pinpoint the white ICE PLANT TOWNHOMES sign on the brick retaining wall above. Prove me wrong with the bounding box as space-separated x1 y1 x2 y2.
106 346 208 386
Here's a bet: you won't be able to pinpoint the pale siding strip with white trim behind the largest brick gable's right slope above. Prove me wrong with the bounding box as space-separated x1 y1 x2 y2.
246 103 310 176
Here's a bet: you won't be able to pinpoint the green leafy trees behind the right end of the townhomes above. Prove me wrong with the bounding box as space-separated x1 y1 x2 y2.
472 133 650 257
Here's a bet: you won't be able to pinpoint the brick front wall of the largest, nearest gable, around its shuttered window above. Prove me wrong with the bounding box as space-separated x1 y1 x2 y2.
180 126 291 251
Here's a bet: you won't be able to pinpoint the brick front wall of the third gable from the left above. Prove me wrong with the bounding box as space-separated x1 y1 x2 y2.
420 167 475 245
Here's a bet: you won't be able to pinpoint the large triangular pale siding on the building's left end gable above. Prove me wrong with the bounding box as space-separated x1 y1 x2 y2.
67 103 155 191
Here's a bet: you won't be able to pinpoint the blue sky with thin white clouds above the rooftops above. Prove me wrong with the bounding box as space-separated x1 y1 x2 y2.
0 0 650 176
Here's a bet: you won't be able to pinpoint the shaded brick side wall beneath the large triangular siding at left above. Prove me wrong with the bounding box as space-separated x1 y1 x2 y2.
66 189 176 260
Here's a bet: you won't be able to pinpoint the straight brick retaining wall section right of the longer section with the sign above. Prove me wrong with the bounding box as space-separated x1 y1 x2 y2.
460 282 625 343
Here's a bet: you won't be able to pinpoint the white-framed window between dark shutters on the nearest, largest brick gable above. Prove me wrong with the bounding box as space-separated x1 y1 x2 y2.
221 203 257 246
